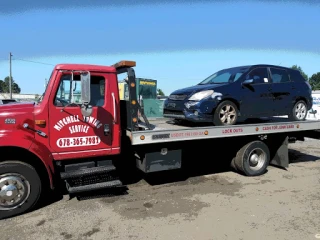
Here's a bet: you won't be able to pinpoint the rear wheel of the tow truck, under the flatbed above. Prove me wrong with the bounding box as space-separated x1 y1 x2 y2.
234 141 270 176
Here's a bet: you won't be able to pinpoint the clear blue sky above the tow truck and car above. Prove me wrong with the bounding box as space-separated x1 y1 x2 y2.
0 0 320 94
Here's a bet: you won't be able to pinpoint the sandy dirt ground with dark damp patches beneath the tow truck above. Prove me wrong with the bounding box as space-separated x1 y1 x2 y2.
0 140 320 240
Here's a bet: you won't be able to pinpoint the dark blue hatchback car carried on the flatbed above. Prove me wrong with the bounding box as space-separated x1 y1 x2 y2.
163 64 312 125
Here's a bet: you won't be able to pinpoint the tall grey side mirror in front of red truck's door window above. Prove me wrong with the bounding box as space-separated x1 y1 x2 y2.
80 72 92 117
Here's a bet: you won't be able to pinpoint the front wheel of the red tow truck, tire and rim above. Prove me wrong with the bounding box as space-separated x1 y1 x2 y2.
0 161 42 219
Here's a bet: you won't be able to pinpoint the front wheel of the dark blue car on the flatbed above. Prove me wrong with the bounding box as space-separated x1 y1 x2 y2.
213 100 238 126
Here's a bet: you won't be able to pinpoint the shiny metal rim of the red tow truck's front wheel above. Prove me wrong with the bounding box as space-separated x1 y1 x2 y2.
0 173 30 210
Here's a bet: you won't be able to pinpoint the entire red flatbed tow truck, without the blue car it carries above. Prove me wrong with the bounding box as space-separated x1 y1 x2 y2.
0 61 320 219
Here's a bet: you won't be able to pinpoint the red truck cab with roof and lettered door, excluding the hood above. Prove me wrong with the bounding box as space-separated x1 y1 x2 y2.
33 64 120 160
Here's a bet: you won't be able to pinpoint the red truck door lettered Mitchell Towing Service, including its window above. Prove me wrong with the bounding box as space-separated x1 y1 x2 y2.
49 72 112 159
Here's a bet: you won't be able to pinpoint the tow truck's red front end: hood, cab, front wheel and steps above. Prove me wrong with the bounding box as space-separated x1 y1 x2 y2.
0 61 135 219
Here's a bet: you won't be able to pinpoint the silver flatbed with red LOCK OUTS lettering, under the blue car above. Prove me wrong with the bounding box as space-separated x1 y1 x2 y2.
127 117 320 145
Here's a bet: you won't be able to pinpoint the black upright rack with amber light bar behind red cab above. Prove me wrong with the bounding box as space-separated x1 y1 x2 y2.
112 60 152 131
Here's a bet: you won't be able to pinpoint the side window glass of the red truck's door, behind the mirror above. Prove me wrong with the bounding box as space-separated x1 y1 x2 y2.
54 74 105 107
